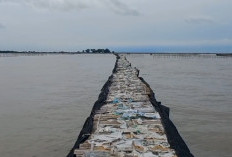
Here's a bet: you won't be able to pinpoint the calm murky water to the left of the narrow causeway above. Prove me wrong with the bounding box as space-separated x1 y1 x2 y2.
0 55 115 157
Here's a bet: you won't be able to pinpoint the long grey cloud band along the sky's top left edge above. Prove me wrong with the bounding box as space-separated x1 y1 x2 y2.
0 0 139 16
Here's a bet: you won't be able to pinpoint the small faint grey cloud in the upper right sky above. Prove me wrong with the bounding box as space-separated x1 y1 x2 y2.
185 17 215 24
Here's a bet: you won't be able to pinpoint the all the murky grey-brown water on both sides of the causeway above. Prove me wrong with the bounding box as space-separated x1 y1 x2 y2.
0 55 232 157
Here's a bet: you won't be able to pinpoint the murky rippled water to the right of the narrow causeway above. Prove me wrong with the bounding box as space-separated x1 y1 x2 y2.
127 55 232 157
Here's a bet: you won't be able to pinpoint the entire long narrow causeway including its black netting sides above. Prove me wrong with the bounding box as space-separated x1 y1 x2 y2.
68 55 193 157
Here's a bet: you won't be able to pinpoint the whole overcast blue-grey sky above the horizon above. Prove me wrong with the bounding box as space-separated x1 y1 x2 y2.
0 0 232 52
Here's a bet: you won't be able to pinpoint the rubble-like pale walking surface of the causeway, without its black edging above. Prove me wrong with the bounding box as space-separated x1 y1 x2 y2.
74 55 177 157
